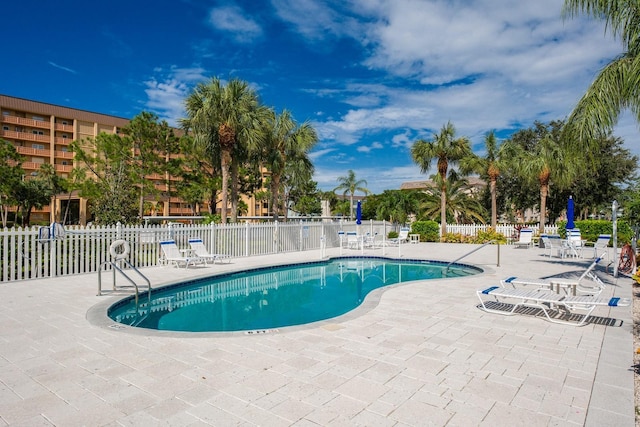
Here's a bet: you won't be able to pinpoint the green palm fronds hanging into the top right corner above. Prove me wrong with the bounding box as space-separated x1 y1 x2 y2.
562 0 640 144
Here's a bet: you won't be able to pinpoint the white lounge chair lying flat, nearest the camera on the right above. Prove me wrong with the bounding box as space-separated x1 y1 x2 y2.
476 286 631 326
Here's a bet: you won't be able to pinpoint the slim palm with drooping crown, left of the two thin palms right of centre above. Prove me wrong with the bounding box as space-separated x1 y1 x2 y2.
411 122 472 235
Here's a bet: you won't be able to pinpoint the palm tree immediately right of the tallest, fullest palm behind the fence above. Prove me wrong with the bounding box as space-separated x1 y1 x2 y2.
263 110 318 221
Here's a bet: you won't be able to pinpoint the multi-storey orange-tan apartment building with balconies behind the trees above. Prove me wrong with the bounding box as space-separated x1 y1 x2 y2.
0 95 268 224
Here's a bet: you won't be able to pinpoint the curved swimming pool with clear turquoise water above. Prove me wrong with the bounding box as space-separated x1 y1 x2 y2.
108 257 482 332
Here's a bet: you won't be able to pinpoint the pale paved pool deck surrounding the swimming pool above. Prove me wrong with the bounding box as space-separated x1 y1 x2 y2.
0 243 635 427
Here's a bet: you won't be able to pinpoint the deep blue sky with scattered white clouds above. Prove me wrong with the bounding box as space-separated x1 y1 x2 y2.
0 0 640 193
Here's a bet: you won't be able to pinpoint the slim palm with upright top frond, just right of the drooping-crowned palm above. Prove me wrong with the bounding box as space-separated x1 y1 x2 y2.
460 131 504 230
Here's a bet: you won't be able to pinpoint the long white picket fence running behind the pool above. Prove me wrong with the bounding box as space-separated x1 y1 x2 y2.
0 221 557 282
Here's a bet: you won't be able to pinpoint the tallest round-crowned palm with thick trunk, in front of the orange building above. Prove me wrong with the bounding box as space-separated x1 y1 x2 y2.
181 77 261 223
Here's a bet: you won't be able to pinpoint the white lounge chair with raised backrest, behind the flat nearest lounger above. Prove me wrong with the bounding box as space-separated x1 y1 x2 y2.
500 252 606 296
